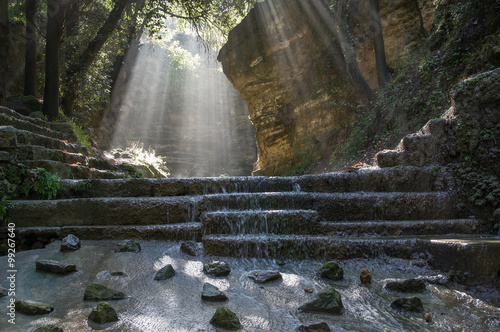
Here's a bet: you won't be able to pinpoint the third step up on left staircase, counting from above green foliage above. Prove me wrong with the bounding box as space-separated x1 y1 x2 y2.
0 126 88 155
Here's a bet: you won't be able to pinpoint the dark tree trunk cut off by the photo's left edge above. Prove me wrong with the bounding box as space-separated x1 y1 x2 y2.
0 0 9 106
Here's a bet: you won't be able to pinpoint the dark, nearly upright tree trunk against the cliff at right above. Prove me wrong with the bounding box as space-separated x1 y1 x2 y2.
370 0 390 88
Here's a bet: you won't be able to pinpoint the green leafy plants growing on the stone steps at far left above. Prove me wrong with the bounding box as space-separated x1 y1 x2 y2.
22 167 61 199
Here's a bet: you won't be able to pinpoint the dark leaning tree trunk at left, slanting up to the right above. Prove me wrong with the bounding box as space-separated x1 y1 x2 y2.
62 0 131 116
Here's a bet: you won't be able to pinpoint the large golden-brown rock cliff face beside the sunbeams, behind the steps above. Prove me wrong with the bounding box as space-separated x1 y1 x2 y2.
218 0 433 175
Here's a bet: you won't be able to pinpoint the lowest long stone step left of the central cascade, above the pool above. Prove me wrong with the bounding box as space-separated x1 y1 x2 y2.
17 223 202 246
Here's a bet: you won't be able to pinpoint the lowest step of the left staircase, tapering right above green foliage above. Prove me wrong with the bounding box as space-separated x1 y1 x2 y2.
20 160 126 179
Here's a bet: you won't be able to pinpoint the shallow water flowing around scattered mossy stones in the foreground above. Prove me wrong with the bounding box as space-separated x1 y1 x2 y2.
0 241 500 332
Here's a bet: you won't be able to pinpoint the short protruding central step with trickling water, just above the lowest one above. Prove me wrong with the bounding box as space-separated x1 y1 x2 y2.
201 210 319 234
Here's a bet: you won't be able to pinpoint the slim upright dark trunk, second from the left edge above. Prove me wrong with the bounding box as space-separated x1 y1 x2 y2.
24 0 37 96
